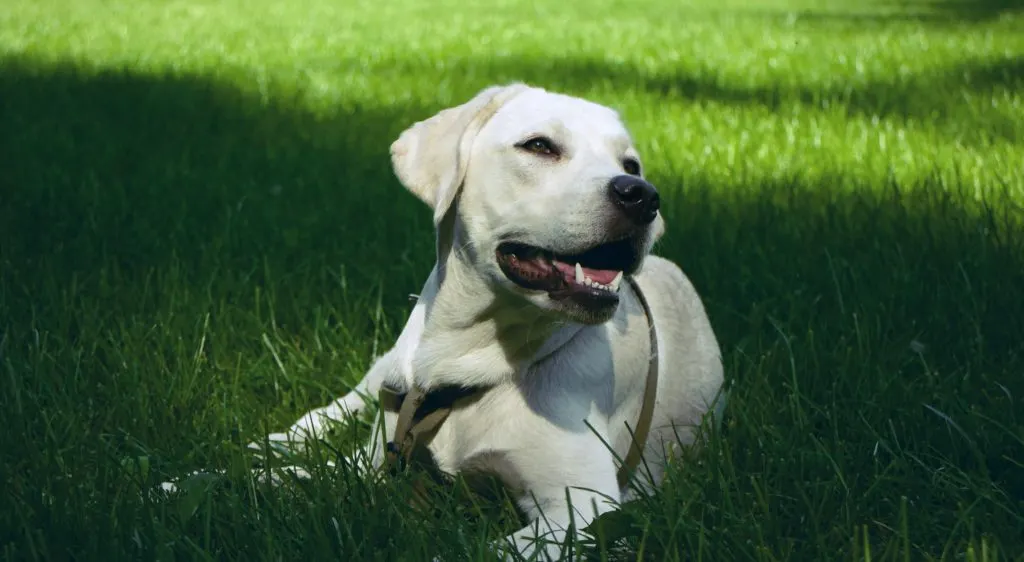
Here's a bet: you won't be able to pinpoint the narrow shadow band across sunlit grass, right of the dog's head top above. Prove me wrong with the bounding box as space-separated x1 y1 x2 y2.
436 56 1024 147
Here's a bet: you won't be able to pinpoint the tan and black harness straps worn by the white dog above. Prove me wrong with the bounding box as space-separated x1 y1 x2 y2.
380 277 658 487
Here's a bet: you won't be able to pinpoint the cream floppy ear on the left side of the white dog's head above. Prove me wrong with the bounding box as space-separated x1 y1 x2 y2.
391 83 528 225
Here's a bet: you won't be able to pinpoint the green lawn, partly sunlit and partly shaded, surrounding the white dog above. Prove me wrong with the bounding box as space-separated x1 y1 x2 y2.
0 0 1024 561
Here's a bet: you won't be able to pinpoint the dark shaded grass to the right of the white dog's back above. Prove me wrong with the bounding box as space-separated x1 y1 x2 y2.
637 176 1024 560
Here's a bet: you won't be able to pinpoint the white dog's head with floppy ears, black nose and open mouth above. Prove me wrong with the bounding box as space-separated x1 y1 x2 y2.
391 84 665 323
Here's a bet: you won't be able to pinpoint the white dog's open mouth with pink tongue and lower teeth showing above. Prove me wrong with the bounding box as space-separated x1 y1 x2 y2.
496 239 639 306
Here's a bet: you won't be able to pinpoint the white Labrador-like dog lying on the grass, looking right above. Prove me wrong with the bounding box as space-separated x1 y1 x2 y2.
174 83 725 558
